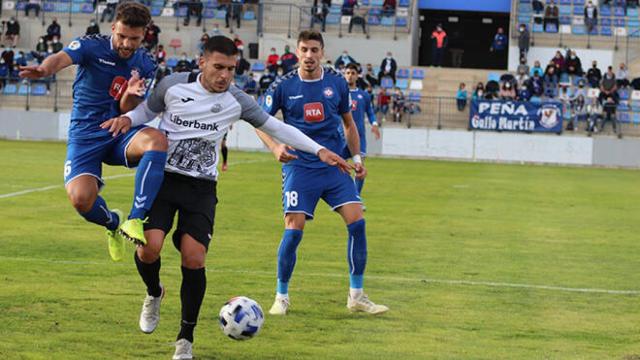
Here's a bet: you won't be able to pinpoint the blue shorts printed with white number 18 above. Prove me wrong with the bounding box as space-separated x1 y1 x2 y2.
282 166 362 220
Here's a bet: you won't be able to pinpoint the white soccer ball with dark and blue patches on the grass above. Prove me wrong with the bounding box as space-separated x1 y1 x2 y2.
220 296 264 340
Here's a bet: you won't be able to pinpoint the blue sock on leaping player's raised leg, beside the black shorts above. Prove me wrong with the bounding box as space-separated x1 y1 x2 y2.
129 151 167 219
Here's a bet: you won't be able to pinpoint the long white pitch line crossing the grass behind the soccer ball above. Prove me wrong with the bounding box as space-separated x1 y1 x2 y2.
0 256 640 295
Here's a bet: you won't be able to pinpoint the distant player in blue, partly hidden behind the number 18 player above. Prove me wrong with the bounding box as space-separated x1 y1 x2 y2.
338 64 380 210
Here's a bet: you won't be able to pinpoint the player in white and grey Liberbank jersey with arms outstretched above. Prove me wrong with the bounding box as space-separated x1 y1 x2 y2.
102 36 351 359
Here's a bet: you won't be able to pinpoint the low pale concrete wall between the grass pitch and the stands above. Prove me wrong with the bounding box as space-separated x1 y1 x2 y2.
0 109 640 169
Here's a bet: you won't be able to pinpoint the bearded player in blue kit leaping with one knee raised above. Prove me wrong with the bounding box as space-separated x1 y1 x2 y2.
20 2 167 261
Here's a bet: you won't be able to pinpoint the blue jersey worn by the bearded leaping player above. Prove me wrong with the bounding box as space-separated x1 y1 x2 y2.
63 34 156 139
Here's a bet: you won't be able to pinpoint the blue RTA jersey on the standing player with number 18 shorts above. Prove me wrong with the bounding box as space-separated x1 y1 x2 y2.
263 67 351 168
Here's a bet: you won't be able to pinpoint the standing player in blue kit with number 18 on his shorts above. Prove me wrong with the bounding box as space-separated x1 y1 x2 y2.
258 30 389 315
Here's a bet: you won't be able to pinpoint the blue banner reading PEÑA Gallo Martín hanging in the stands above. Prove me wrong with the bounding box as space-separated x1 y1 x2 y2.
469 100 562 133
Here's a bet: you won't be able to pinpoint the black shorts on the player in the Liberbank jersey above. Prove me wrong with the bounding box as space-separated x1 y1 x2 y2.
144 171 218 251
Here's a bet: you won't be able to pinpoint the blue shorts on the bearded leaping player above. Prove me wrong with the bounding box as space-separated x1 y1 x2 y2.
64 126 146 187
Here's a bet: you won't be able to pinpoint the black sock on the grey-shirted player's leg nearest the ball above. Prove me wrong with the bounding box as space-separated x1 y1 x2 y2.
176 266 207 342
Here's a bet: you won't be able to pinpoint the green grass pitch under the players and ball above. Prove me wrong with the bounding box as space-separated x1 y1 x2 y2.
0 141 640 359
